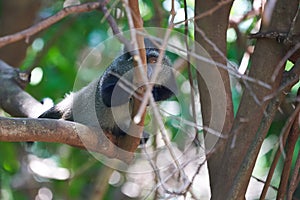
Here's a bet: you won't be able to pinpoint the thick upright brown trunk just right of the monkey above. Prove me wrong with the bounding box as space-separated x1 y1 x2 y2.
195 0 234 195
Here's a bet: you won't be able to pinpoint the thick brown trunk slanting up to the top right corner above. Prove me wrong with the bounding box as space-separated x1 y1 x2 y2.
212 0 298 199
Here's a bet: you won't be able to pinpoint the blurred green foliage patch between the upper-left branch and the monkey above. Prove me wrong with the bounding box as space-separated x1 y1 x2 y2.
23 12 108 102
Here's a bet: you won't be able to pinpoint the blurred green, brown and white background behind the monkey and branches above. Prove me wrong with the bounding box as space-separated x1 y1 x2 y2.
0 0 300 200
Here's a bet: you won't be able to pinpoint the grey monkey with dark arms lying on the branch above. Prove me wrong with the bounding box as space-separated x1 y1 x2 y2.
39 39 177 143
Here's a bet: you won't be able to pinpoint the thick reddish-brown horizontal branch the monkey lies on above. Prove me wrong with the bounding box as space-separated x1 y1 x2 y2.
0 117 127 161
